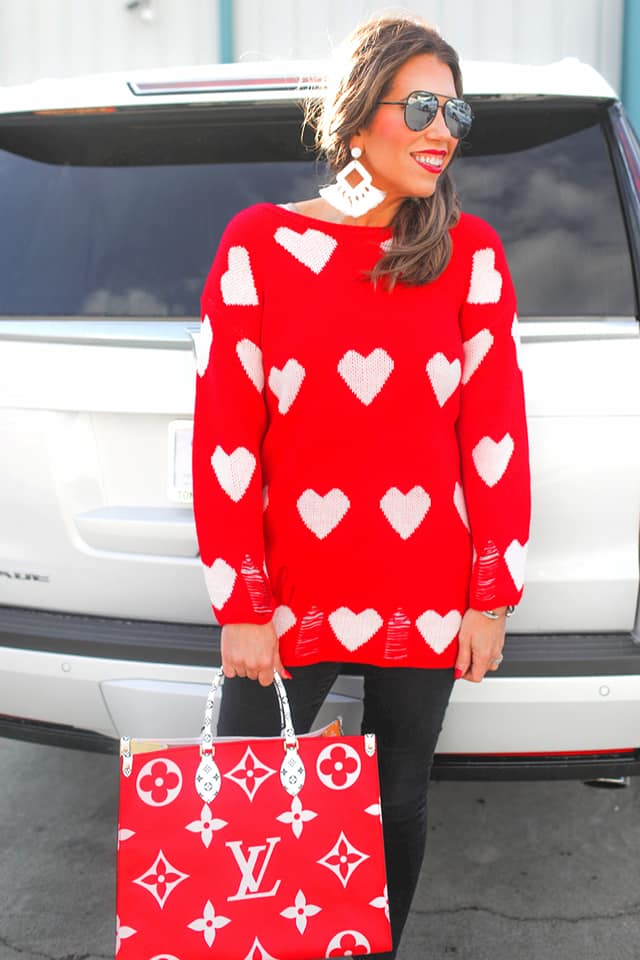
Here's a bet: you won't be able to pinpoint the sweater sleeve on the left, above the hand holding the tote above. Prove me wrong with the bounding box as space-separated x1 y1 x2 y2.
193 211 274 624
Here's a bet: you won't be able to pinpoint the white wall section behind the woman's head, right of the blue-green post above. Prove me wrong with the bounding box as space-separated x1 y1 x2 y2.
234 0 624 89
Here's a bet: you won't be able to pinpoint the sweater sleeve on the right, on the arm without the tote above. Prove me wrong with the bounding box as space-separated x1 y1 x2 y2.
458 221 531 610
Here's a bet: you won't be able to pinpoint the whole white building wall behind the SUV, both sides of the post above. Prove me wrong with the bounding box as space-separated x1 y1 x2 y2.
0 0 624 89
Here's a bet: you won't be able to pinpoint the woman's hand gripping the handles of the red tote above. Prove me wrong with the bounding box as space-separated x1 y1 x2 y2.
221 623 291 687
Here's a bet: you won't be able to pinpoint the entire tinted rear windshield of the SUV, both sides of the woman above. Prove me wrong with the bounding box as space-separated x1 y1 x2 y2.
0 103 636 318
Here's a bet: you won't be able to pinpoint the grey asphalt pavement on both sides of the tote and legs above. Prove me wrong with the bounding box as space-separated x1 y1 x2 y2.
0 739 640 960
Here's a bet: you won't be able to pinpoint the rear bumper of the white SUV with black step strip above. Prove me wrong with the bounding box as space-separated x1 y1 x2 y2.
0 607 640 779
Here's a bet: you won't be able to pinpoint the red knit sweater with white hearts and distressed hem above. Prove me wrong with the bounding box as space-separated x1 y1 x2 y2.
193 204 530 667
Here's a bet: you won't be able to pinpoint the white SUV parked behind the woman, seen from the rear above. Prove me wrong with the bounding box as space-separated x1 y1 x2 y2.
0 61 640 777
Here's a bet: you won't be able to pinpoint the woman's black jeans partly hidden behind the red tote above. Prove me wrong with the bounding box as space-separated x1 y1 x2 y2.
218 663 453 958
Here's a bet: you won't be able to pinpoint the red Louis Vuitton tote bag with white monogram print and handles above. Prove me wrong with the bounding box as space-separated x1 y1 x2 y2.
116 671 391 960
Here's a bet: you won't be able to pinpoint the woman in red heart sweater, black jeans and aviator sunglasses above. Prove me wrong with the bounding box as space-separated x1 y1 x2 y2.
193 11 529 949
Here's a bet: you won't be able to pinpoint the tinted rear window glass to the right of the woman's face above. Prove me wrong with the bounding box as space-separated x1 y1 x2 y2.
454 118 636 317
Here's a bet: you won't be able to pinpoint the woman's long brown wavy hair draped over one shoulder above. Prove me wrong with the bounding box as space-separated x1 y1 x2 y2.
305 16 462 289
